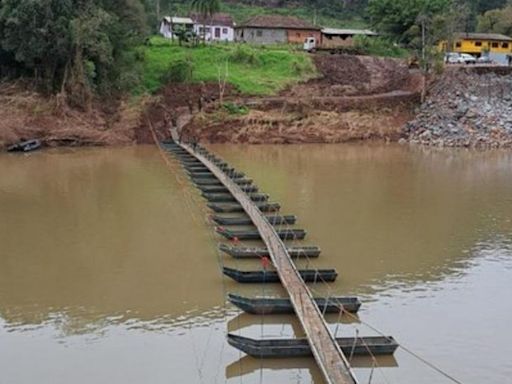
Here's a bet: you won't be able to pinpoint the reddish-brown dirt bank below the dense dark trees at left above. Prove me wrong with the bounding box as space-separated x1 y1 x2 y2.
0 83 144 148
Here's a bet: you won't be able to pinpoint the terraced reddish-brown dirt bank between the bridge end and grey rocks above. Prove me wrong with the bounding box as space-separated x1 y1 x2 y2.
178 55 422 144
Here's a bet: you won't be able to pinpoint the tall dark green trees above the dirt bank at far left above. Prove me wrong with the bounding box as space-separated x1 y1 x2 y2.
0 0 146 105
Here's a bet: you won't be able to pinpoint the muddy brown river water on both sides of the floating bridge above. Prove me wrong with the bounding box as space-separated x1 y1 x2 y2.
0 145 512 384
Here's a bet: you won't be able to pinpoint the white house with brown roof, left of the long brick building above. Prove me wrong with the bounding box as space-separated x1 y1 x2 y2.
192 13 235 41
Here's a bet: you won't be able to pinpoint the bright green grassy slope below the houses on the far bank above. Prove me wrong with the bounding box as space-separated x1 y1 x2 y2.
143 37 316 95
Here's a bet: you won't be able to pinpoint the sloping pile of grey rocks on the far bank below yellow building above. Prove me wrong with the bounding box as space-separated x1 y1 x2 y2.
403 67 512 148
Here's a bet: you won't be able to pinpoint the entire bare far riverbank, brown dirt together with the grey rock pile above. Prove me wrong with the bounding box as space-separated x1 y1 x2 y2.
6 54 512 148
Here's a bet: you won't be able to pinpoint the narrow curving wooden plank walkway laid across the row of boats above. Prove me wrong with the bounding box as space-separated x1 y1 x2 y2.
174 144 357 384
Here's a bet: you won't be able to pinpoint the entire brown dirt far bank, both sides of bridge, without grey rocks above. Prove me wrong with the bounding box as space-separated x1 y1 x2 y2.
0 55 422 147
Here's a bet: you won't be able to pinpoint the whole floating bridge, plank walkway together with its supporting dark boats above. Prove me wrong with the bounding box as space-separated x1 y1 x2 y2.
161 140 397 384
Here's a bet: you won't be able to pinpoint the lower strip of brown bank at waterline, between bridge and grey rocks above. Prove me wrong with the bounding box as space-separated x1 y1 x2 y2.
189 109 410 144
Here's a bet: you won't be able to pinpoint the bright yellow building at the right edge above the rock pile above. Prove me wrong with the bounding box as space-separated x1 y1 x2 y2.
440 33 512 57
